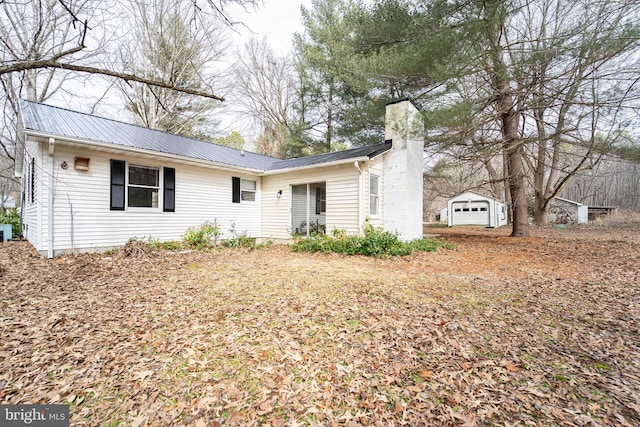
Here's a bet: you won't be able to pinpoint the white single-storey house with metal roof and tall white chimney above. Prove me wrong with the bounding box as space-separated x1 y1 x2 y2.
21 100 423 258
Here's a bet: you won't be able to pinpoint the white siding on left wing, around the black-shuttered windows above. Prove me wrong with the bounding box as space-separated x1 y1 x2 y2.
32 142 261 253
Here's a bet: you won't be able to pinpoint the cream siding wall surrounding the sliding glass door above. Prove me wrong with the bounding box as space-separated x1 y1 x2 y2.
262 163 361 240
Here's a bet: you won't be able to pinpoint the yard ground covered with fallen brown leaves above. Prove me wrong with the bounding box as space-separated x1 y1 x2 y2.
0 221 640 426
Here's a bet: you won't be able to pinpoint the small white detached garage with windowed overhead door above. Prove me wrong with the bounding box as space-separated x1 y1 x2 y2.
447 191 506 228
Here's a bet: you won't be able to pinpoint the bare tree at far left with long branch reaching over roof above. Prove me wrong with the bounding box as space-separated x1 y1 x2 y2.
0 0 261 186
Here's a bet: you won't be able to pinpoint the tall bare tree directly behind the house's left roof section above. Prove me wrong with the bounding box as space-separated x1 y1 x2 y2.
118 0 229 139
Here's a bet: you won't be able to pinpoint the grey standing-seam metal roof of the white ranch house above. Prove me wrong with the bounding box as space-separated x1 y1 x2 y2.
21 100 391 171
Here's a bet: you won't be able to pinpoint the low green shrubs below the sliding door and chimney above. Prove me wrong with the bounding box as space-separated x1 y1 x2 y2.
291 222 450 257
